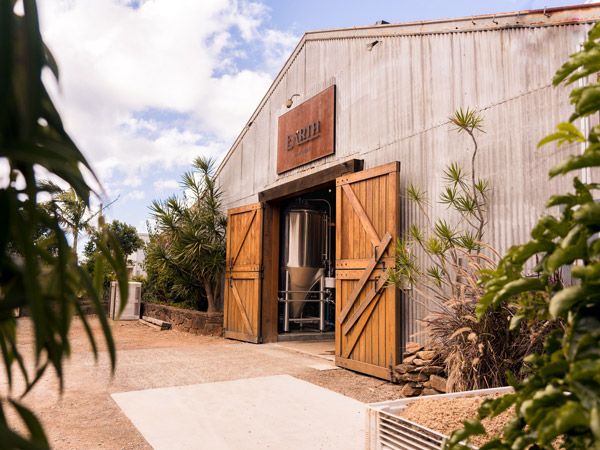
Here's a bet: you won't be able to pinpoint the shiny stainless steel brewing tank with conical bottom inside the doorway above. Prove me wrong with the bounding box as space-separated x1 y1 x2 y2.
281 208 329 318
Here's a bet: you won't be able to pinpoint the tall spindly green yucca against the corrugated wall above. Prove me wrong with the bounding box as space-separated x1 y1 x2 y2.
390 108 490 303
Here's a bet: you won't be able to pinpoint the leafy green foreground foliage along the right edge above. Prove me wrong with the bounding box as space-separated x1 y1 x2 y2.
444 25 600 450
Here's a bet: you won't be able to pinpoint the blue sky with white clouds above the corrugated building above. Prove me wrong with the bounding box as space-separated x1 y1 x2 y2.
39 0 583 250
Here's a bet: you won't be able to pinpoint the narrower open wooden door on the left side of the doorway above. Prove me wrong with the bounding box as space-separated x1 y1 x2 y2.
223 203 263 343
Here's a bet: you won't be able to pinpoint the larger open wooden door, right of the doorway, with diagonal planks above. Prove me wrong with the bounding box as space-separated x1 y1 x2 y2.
335 162 401 379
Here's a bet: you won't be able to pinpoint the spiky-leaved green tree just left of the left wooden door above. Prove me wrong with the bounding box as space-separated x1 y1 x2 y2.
148 158 227 312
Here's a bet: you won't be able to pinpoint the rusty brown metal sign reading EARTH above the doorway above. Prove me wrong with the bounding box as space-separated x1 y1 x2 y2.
277 85 335 174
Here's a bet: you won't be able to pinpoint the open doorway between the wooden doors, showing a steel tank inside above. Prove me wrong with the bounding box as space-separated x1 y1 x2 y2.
277 185 336 341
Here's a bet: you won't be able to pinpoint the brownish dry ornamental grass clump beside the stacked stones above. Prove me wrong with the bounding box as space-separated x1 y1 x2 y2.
412 249 558 392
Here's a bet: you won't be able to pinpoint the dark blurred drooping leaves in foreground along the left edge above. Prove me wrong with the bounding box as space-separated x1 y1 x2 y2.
0 0 127 449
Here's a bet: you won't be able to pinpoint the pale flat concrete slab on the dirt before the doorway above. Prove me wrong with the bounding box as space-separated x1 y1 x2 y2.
112 375 365 450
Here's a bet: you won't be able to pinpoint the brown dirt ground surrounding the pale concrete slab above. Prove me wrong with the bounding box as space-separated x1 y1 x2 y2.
0 319 401 450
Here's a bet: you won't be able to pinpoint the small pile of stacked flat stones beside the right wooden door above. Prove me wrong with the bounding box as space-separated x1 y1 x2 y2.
394 342 446 397
